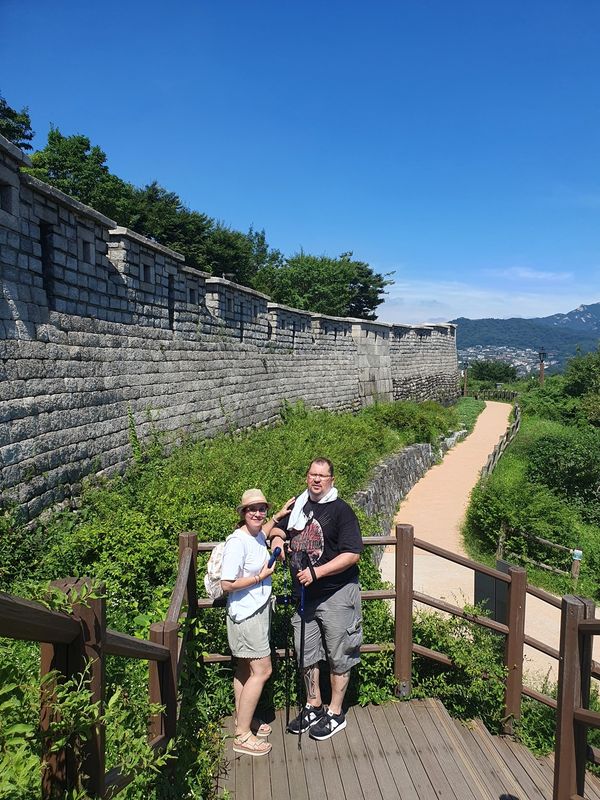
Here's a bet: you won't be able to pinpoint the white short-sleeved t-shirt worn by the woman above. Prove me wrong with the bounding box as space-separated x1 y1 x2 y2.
221 528 271 622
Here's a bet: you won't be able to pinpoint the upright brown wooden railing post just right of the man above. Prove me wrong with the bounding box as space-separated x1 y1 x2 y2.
394 525 415 697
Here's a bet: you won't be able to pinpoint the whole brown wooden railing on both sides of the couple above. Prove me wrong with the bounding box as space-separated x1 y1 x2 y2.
0 525 600 800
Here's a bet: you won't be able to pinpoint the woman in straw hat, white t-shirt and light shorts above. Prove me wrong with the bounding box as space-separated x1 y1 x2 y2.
221 489 275 756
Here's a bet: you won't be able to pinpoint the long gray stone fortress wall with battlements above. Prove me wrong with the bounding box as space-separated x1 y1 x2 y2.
0 136 458 517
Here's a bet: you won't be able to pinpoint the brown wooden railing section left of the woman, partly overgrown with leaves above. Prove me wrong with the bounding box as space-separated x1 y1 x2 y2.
0 533 198 800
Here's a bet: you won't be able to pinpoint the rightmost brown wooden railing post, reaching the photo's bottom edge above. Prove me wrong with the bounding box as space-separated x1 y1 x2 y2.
552 595 585 800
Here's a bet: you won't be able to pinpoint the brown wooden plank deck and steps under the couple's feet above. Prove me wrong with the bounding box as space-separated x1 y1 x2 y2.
219 700 600 800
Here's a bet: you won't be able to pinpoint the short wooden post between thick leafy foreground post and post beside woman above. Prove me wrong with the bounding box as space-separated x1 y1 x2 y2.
148 622 179 739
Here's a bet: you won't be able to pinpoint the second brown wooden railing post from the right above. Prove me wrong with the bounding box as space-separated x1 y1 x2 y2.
503 567 527 735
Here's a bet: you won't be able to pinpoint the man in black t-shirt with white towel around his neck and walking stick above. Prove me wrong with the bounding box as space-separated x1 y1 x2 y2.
269 458 363 740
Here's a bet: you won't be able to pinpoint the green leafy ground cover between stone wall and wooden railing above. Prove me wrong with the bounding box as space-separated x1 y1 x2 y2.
0 400 502 800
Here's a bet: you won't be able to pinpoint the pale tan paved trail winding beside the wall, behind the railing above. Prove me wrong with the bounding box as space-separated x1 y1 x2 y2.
380 402 600 680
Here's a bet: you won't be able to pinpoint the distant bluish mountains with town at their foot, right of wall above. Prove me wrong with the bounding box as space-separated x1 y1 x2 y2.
452 303 600 364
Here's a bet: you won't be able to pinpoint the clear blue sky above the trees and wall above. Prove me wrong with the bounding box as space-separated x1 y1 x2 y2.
0 0 600 322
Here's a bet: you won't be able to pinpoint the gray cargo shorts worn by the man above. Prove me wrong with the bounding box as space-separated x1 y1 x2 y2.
292 583 362 674
